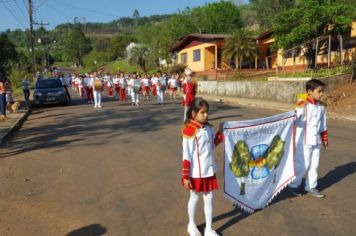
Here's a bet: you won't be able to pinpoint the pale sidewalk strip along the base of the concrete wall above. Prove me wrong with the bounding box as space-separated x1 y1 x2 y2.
199 94 356 122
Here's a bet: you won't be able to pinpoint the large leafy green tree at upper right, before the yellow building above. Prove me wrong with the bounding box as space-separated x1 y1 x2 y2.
274 0 356 68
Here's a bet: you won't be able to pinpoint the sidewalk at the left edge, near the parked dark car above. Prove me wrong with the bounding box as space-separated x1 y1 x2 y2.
0 98 31 144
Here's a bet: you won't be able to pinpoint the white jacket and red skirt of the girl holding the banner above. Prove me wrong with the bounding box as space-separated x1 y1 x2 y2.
182 121 224 192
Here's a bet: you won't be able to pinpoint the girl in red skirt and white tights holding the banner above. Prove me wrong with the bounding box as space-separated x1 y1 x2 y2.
182 98 224 236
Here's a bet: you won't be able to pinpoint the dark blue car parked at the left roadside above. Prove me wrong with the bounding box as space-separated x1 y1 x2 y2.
33 79 69 106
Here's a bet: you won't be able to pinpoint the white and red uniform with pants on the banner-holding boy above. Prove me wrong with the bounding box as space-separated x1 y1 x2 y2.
289 97 328 191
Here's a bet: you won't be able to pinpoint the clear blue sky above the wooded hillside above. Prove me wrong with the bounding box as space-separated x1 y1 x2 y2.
0 0 247 31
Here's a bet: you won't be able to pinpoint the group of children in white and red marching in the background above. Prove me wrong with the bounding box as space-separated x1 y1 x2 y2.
71 69 195 108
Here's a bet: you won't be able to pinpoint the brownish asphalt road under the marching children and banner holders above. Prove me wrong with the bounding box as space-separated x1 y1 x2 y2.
0 92 356 236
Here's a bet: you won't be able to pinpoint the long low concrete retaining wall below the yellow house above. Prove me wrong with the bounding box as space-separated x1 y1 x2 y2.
198 74 350 103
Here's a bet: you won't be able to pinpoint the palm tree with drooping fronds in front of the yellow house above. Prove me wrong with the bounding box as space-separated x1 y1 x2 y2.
222 29 257 69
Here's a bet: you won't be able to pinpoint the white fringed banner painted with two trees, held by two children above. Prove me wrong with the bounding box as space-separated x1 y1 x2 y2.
223 111 296 213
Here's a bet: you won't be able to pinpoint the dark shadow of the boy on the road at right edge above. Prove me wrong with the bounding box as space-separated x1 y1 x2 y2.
318 162 356 190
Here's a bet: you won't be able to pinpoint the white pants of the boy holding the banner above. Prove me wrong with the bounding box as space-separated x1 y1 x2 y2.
289 145 320 191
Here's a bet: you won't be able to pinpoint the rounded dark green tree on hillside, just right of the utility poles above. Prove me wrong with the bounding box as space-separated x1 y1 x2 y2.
64 26 91 66
